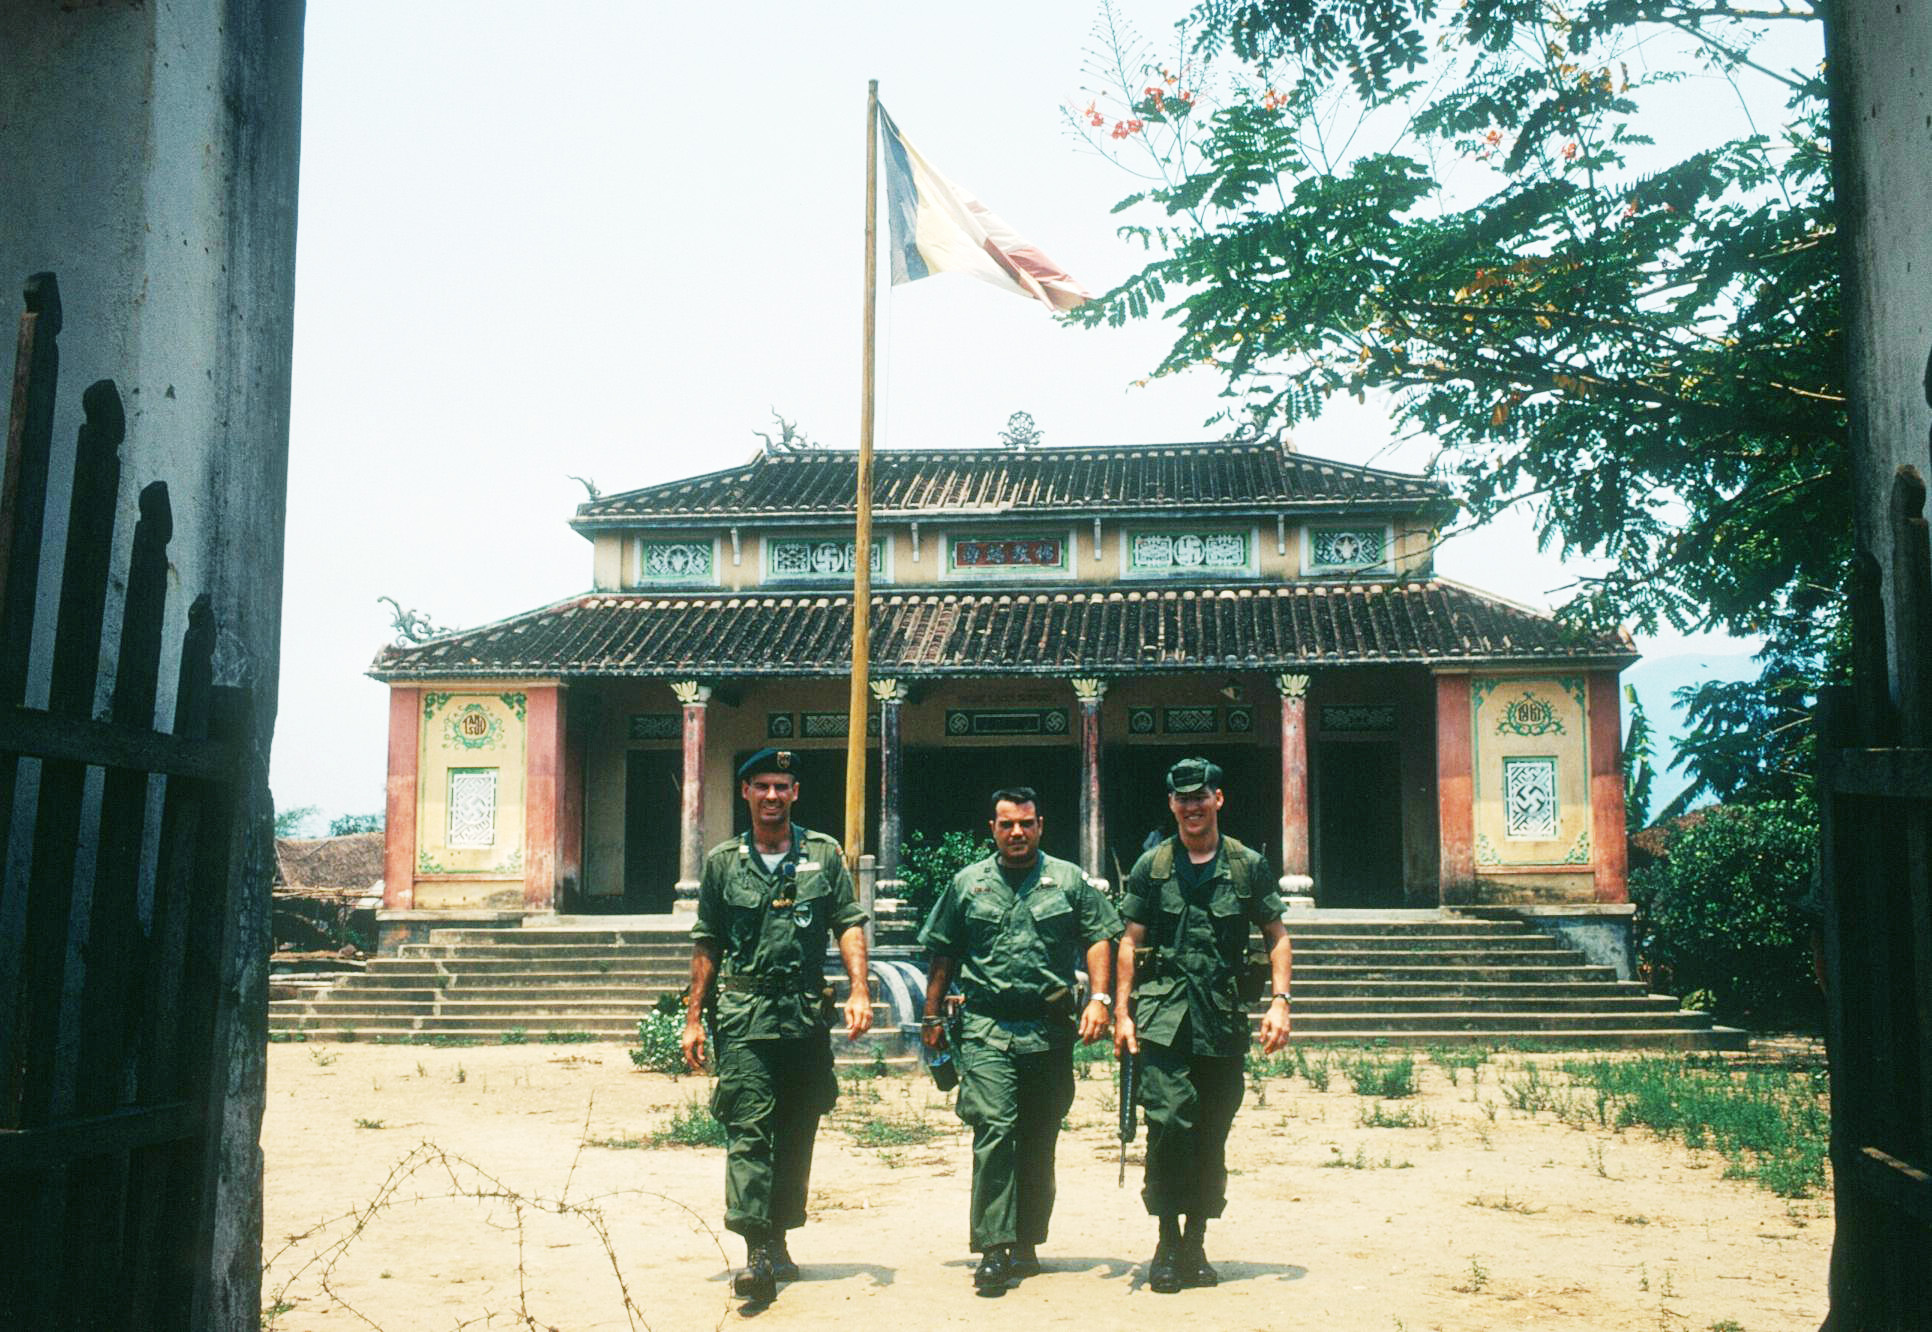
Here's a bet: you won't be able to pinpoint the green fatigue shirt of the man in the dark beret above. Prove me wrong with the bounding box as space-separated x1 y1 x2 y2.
692 824 866 1040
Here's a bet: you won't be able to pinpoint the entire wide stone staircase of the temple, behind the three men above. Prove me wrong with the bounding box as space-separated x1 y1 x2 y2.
269 912 1745 1061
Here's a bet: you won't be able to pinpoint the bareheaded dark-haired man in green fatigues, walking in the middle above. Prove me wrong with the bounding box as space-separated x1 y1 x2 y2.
920 787 1121 1295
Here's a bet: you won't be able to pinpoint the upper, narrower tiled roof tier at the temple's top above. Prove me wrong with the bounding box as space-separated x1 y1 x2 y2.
572 443 1449 530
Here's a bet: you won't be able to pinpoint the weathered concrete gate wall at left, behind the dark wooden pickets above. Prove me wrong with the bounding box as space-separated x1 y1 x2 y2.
0 0 303 1328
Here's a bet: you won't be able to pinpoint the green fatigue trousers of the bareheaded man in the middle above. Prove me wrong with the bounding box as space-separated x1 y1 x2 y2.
956 1040 1074 1253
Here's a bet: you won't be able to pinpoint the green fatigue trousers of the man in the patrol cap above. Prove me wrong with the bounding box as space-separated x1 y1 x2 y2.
1140 1040 1246 1218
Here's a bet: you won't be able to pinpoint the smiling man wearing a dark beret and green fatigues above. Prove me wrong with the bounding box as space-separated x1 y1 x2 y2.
682 750 871 1303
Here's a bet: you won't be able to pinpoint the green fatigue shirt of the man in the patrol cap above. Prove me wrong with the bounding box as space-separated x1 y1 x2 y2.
1121 837 1283 1056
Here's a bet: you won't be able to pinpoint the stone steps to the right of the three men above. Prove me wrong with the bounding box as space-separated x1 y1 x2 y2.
1256 912 1745 1050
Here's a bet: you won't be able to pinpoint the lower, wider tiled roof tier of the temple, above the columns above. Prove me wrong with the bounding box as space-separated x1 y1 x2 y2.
369 580 1636 680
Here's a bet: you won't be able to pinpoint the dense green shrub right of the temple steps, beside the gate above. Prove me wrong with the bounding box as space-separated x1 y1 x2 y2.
1631 800 1820 1027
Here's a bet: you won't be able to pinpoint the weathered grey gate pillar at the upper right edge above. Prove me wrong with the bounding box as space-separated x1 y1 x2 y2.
1826 0 1932 676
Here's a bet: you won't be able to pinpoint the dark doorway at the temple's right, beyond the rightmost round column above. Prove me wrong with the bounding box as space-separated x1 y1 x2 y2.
1314 740 1403 907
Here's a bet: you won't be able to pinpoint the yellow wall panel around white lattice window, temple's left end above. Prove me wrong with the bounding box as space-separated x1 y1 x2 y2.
415 690 526 907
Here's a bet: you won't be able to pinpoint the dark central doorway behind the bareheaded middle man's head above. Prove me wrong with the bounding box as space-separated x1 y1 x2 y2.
904 744 1080 860
